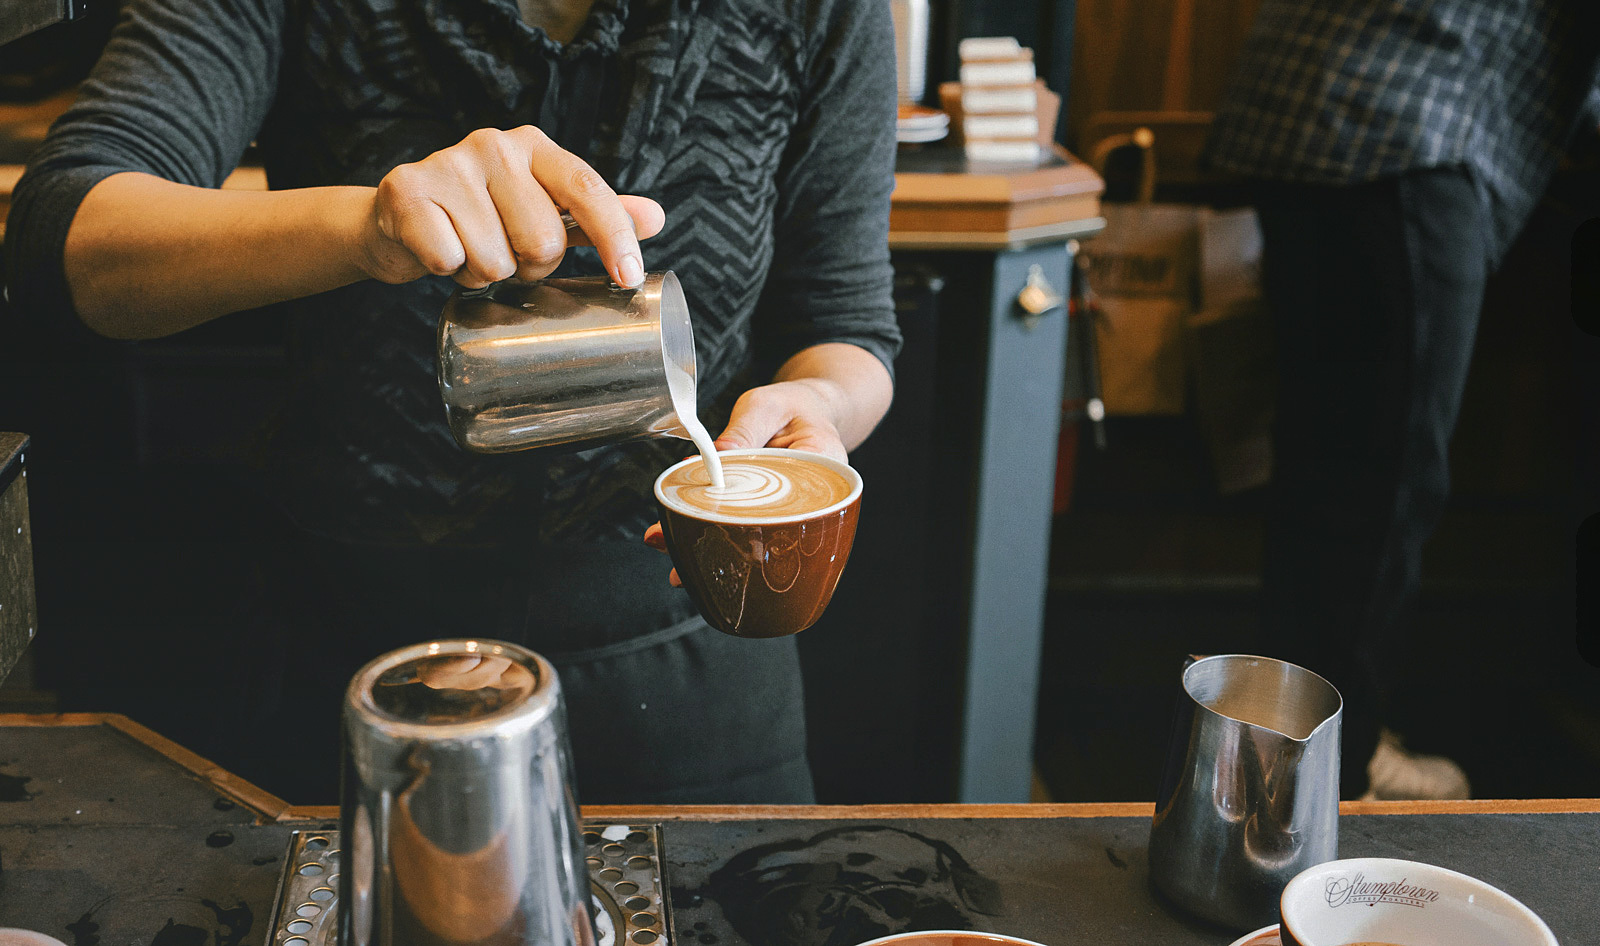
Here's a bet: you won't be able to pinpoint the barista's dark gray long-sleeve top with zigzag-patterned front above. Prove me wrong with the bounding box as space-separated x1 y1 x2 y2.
6 0 899 544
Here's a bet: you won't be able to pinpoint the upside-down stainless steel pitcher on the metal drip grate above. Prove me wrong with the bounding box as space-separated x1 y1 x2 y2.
338 640 595 946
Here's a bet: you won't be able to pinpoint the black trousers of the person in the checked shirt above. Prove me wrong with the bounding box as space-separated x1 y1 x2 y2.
1258 168 1490 797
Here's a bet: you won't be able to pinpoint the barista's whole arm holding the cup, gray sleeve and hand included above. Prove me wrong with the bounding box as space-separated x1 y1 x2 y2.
736 2 901 459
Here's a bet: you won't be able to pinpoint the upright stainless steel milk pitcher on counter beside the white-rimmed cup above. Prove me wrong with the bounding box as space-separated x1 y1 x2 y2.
1150 655 1344 930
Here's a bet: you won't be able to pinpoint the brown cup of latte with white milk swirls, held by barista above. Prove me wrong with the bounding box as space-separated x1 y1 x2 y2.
656 447 861 637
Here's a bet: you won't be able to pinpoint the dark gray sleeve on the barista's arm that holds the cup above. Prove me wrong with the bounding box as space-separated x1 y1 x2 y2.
755 0 901 376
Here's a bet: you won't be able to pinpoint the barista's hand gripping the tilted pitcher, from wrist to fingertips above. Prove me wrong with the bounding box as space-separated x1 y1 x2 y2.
362 125 666 288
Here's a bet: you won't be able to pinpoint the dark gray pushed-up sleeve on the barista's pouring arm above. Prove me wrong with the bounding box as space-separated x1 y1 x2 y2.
5 0 285 331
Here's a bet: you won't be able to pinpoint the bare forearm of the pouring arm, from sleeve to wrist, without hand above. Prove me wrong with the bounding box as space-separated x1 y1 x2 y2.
64 173 373 338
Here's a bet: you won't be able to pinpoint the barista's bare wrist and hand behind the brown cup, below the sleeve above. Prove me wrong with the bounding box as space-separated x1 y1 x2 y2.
717 343 894 459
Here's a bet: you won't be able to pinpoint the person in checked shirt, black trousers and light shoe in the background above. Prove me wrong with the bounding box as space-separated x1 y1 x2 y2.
1205 0 1600 797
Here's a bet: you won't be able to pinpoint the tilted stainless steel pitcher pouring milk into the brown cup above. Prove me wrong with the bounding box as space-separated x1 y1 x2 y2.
438 272 707 453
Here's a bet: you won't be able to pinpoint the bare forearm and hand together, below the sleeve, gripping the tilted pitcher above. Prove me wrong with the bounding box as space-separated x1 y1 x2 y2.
62 142 662 338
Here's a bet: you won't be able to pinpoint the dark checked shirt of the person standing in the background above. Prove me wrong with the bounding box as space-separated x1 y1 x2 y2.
1206 0 1600 256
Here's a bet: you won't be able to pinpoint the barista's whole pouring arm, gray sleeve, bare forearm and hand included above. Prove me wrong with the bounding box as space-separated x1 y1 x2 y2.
6 0 661 338
